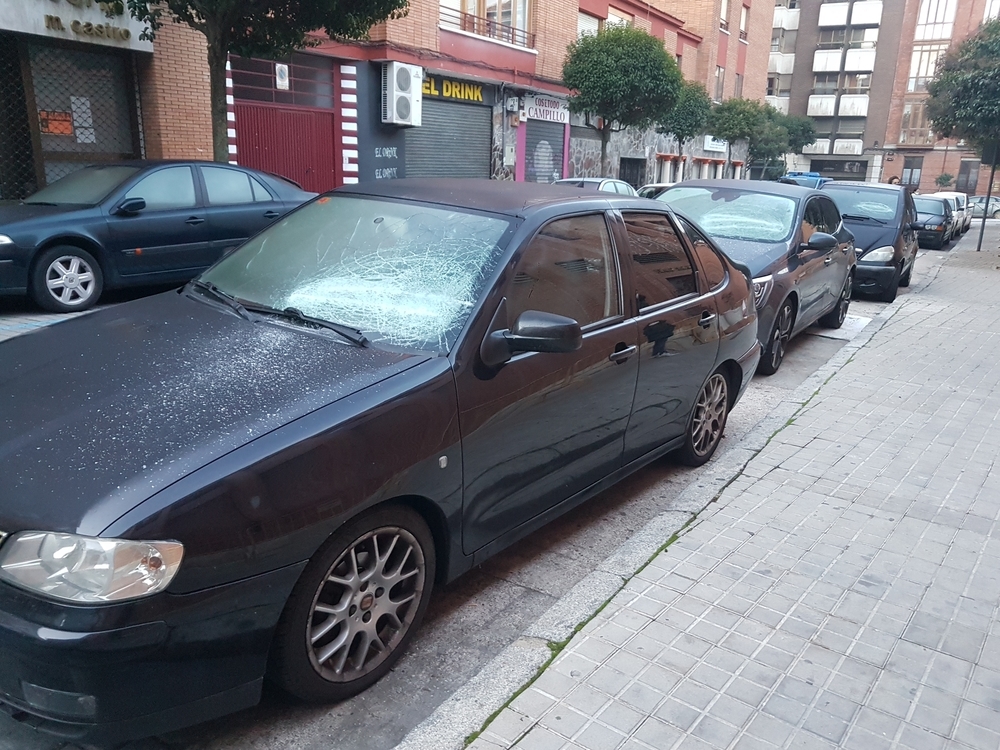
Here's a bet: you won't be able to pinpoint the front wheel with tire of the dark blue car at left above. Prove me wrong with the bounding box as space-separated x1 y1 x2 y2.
31 245 104 312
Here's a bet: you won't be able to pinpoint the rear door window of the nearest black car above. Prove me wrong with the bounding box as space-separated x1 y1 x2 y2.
623 213 697 313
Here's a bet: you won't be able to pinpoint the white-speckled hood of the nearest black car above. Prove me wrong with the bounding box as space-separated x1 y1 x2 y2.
0 292 428 535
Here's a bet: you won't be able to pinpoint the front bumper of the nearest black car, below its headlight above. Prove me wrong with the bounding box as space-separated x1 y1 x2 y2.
0 563 305 743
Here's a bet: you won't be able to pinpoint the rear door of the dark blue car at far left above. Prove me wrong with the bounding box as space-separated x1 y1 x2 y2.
199 166 285 263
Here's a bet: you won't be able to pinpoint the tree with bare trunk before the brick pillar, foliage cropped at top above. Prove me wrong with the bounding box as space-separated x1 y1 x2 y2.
125 0 407 161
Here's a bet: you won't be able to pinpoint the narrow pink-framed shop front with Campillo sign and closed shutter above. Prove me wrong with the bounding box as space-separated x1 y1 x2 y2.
515 95 569 182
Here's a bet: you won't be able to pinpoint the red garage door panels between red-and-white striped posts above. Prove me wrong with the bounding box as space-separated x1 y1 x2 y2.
235 100 339 193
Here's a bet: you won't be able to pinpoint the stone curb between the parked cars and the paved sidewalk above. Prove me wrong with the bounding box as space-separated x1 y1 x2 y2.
396 257 948 750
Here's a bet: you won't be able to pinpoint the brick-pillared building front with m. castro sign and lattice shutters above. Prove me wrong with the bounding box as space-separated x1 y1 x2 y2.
0 0 212 200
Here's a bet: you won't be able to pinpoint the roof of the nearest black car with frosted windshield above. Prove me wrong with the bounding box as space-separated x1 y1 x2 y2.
335 178 644 216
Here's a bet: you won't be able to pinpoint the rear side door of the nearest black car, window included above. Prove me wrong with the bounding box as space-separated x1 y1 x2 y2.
622 212 719 463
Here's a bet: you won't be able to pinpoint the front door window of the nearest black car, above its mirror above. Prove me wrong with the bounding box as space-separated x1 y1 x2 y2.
507 214 621 326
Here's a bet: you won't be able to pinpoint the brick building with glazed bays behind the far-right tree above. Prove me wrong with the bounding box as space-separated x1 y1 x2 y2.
880 0 1000 195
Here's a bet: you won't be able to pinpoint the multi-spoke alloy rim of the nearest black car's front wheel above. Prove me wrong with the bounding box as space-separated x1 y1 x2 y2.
306 527 426 682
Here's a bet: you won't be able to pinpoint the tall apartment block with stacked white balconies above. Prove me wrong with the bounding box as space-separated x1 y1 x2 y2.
767 0 908 180
